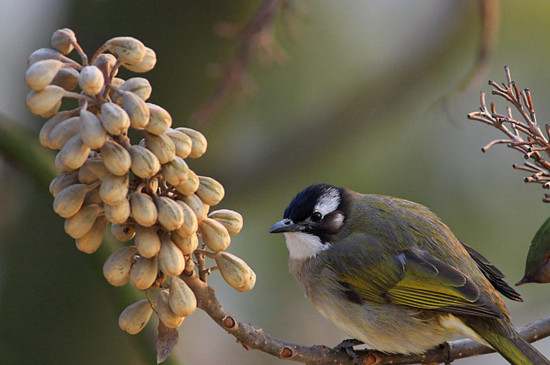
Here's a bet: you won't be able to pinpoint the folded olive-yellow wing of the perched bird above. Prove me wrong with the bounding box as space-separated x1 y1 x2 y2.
337 251 502 317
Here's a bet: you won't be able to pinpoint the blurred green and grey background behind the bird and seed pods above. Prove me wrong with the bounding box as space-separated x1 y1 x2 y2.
0 0 550 364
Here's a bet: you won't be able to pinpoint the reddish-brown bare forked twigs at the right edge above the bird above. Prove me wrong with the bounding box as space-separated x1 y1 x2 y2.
468 67 550 203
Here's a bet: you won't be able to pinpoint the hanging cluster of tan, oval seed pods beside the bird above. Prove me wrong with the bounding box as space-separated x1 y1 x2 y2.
25 29 256 334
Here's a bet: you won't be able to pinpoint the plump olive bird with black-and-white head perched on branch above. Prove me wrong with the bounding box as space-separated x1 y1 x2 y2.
269 183 550 365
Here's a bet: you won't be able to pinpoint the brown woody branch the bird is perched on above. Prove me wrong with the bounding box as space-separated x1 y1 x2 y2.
181 275 550 365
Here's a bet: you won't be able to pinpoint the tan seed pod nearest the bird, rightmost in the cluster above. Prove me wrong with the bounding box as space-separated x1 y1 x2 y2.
214 252 256 292
